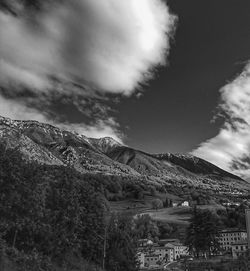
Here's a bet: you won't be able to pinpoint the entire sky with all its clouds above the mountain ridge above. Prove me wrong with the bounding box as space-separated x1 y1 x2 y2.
0 0 250 181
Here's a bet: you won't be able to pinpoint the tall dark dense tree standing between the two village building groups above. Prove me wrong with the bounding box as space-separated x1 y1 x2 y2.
186 208 219 257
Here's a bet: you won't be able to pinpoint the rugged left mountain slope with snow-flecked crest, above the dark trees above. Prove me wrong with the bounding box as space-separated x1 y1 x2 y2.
0 118 139 175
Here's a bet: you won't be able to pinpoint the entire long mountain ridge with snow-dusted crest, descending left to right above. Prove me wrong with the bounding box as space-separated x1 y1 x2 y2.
0 117 249 199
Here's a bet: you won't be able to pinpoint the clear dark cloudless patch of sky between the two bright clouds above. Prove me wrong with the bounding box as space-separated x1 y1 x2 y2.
117 0 250 153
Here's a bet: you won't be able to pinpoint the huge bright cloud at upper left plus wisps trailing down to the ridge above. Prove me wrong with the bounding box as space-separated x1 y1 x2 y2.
0 0 176 140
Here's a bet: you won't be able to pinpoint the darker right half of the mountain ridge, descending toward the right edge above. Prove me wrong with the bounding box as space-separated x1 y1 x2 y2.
106 146 248 196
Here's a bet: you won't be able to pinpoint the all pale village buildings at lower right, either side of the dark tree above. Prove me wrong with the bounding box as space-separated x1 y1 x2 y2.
137 211 250 271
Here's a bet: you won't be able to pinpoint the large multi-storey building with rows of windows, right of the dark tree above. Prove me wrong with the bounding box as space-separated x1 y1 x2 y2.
219 229 247 251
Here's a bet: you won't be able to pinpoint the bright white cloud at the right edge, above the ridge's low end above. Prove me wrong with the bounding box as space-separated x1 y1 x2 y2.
193 65 250 179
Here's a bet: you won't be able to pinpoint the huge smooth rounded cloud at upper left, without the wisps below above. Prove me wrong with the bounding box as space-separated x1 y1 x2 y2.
0 0 175 94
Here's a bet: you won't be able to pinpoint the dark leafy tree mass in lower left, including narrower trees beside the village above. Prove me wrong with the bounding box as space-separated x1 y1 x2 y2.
0 145 141 271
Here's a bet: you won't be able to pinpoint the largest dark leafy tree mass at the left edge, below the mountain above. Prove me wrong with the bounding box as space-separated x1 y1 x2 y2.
0 145 105 264
